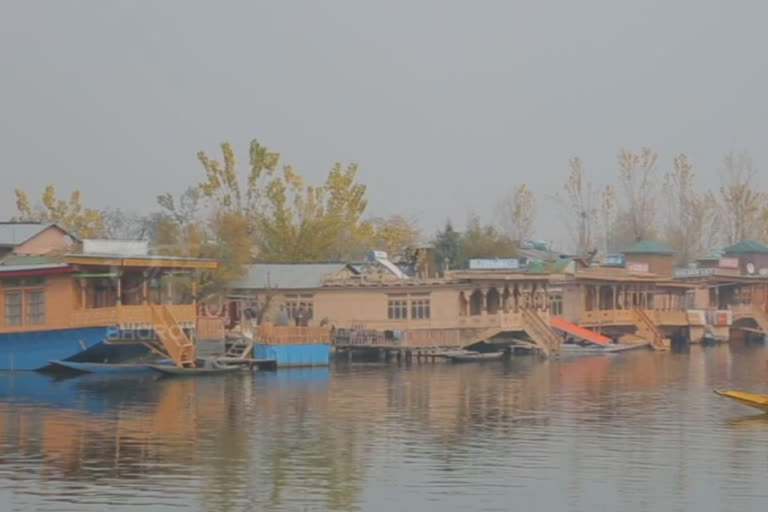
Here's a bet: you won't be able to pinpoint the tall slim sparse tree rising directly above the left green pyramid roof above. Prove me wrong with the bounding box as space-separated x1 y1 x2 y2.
619 147 658 240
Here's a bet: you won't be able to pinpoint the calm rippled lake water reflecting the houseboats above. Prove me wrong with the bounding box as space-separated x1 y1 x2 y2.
0 343 768 512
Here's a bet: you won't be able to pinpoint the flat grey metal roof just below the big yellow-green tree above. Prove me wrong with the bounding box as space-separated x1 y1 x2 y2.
232 263 347 290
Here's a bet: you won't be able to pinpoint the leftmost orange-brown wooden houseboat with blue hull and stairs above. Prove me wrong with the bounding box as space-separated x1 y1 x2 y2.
0 240 217 370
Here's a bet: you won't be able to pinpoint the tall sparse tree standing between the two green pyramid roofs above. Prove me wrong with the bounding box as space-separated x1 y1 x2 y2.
664 154 719 265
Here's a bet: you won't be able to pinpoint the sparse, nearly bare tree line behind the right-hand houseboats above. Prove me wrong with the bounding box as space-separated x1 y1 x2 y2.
433 147 768 267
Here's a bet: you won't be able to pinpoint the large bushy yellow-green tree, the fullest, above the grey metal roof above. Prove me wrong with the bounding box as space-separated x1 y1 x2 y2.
198 140 371 262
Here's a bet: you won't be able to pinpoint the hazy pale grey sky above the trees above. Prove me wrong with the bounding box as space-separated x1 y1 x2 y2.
0 0 768 248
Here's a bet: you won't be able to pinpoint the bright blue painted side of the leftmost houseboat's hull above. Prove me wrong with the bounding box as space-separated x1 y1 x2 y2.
0 327 110 370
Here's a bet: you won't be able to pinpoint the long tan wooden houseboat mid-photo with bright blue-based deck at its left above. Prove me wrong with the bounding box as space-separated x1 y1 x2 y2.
225 253 562 360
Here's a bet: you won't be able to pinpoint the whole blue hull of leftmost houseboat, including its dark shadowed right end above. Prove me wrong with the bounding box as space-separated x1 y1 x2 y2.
0 327 149 371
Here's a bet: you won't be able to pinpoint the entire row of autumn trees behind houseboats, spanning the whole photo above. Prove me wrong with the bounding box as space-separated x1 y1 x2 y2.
14 140 768 286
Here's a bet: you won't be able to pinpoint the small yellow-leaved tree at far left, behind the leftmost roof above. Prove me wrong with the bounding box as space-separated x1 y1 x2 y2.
11 185 104 238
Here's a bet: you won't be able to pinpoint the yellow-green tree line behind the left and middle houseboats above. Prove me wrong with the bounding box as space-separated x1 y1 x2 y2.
12 140 420 289
